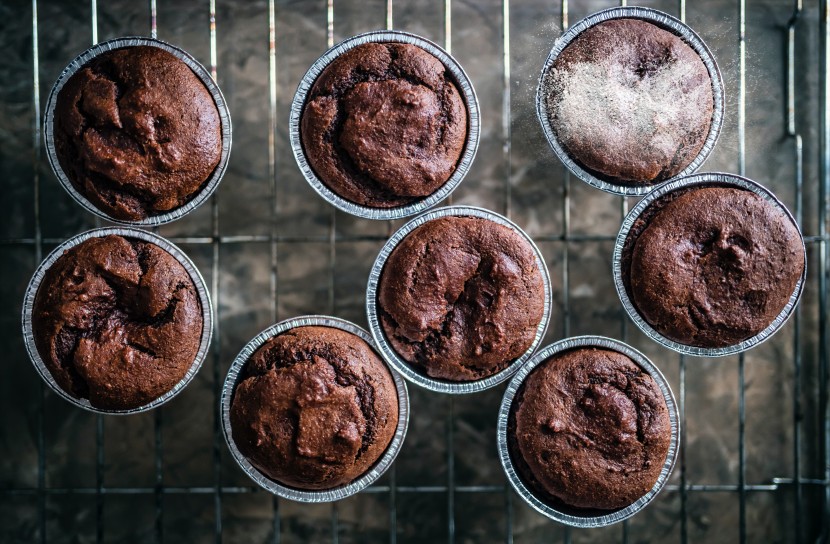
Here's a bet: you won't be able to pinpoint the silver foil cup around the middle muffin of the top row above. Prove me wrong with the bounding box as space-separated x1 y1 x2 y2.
289 30 480 219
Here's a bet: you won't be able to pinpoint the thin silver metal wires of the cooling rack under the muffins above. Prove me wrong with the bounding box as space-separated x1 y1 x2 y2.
0 0 830 543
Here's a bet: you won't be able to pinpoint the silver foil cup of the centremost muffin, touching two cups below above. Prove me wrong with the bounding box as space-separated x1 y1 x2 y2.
366 206 551 394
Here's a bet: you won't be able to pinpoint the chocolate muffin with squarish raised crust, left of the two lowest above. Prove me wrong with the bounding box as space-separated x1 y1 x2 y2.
230 326 398 490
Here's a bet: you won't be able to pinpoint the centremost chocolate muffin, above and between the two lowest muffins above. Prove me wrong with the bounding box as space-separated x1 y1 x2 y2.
378 216 545 382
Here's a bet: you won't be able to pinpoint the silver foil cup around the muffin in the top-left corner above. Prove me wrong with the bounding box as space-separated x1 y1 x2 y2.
43 36 231 227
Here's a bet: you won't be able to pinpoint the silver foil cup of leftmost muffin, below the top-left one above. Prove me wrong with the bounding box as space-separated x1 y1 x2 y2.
23 227 213 415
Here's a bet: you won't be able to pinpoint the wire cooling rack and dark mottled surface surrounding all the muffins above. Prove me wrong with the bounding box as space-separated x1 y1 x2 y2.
0 0 830 543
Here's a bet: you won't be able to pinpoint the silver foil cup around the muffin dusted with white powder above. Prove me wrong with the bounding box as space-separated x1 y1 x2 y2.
536 7 724 196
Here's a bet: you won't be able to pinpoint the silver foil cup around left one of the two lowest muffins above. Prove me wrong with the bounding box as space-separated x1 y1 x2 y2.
219 315 409 502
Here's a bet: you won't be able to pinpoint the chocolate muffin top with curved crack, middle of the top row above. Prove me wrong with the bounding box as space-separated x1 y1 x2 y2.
300 43 467 208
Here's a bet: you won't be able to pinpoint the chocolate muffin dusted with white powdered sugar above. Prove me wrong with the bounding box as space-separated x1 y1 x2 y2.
543 19 714 185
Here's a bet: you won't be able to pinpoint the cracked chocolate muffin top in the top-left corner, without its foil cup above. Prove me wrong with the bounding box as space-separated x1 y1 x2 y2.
54 46 222 221
